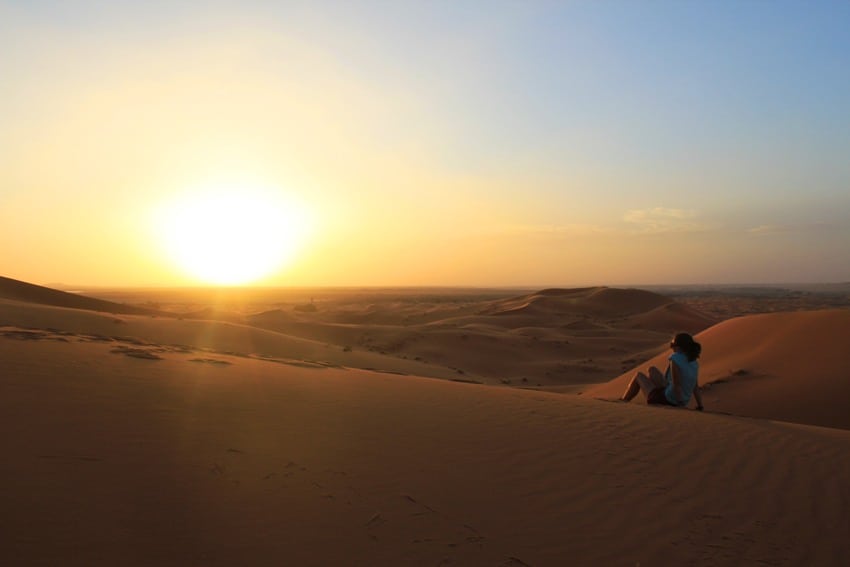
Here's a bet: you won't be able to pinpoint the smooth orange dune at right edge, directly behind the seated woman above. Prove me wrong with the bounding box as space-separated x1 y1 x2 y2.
585 309 850 429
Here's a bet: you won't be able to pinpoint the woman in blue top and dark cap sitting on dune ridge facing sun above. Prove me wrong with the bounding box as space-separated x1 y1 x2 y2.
621 333 702 411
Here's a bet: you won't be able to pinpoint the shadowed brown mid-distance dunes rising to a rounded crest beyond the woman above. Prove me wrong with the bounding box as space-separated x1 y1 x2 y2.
246 287 715 387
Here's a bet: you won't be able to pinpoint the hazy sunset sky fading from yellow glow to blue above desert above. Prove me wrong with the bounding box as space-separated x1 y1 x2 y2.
0 0 850 287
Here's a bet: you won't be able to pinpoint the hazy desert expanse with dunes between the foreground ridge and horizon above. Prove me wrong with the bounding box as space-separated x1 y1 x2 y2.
7 276 850 390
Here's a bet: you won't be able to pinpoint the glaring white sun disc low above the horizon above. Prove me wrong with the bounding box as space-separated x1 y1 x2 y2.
157 187 307 285
